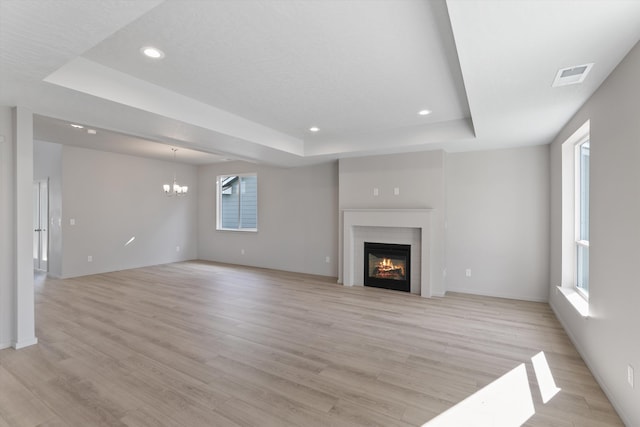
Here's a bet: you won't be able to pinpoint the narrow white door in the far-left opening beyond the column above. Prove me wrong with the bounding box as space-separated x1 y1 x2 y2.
33 179 49 271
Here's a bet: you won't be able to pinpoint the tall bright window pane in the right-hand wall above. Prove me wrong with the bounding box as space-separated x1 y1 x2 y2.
575 139 589 296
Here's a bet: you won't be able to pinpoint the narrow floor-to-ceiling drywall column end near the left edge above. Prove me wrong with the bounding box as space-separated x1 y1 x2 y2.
13 107 38 349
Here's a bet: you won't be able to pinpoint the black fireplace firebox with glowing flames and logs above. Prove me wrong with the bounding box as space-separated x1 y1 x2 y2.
364 242 411 292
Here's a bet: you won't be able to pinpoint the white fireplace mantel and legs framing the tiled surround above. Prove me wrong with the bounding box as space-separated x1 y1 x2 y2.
342 209 433 297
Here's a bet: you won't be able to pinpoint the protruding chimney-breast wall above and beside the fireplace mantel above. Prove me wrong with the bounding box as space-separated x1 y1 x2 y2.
339 151 445 295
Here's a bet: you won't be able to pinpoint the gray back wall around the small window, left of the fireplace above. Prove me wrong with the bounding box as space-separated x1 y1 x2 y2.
198 162 338 277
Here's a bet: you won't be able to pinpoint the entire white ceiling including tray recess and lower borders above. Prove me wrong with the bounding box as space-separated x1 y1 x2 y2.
0 0 640 166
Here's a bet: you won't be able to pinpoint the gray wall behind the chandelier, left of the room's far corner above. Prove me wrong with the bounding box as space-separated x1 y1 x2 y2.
62 146 198 277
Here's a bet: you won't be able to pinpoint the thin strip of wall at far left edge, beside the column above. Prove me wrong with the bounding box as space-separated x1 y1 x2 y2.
0 107 16 349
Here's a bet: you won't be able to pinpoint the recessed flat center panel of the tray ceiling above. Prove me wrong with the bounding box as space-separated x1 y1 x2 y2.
83 0 469 138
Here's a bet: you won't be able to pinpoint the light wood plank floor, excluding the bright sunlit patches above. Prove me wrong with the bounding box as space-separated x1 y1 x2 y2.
0 262 622 427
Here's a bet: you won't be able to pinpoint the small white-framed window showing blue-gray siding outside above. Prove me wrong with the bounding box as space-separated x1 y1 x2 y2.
217 174 258 231
